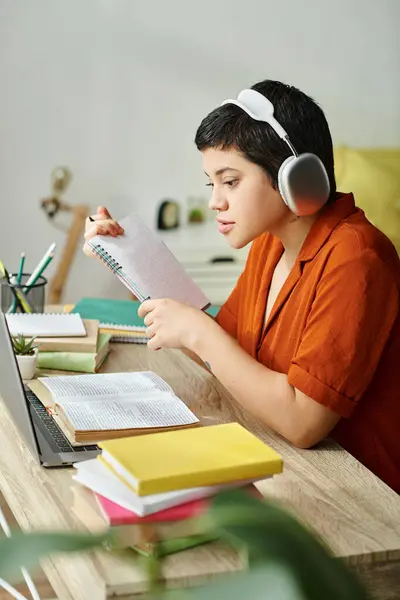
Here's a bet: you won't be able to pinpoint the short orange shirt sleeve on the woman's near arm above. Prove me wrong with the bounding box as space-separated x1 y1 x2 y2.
288 250 399 417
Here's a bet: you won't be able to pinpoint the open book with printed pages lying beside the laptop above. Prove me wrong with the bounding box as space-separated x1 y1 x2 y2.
28 371 199 444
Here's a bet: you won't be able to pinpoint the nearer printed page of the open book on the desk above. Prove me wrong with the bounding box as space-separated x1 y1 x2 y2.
59 391 198 431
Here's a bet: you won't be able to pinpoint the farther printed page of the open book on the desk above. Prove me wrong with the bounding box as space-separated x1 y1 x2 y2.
39 371 173 403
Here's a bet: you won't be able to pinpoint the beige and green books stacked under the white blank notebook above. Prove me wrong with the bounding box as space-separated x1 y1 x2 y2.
36 319 112 373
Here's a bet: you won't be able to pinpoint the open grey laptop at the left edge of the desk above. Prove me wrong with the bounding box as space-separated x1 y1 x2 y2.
0 313 100 467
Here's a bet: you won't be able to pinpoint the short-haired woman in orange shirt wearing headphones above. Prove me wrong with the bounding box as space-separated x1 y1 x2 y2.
85 80 400 492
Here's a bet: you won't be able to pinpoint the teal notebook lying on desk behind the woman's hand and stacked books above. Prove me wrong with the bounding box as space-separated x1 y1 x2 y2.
71 298 220 330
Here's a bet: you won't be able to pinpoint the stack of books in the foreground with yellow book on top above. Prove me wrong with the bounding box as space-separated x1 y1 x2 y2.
72 423 283 554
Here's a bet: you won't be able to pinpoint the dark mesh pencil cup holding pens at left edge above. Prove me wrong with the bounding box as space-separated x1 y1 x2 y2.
0 273 47 313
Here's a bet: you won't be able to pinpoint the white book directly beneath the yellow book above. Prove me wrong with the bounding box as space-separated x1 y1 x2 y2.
73 458 262 517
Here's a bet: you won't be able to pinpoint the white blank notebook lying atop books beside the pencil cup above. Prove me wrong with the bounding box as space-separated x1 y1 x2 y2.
6 313 86 337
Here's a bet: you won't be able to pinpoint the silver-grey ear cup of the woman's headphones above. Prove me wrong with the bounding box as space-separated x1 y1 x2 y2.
278 152 330 217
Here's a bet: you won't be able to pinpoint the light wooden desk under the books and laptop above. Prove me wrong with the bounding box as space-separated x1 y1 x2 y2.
0 344 400 600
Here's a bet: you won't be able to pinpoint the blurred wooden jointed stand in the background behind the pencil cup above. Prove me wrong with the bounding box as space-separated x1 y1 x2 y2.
40 167 90 304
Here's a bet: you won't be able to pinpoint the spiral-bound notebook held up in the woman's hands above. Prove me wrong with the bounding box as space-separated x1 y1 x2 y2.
88 214 210 309
